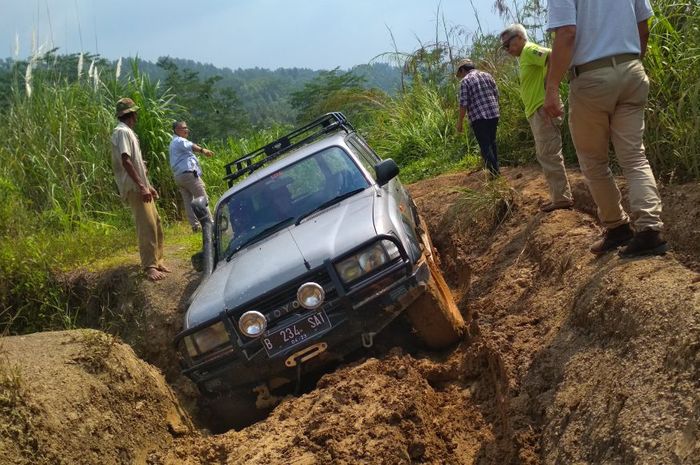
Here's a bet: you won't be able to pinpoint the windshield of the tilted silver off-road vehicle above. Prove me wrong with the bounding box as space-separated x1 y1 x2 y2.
216 146 369 260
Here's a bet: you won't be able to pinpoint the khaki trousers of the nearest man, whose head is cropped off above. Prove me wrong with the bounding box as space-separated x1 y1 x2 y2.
569 60 663 231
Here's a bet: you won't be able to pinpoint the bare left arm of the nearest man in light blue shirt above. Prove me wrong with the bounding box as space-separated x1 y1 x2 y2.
544 26 576 117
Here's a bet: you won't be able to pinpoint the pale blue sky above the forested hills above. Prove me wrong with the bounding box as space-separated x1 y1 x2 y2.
0 0 505 69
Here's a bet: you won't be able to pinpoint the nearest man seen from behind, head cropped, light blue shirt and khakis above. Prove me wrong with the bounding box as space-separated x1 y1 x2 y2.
544 0 667 257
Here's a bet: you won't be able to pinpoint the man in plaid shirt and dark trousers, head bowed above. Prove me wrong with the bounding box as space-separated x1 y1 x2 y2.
457 59 500 176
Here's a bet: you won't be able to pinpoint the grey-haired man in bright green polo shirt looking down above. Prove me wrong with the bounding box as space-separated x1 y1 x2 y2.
501 24 574 212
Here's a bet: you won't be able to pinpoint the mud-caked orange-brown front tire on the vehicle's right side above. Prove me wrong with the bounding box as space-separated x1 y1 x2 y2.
406 218 466 350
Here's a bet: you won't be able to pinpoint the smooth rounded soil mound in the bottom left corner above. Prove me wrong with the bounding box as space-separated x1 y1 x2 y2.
0 330 191 465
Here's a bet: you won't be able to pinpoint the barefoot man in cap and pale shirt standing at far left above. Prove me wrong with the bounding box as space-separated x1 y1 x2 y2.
112 98 170 281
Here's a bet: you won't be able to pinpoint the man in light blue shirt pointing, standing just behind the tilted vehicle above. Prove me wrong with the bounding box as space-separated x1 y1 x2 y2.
170 121 214 232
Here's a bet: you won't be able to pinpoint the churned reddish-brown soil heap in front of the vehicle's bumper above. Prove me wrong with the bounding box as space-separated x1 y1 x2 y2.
154 345 508 465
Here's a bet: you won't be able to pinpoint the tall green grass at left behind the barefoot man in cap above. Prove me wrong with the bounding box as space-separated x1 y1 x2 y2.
0 54 177 332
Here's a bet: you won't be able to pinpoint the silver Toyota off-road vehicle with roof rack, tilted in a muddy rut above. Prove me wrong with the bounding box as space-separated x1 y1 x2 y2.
175 113 464 425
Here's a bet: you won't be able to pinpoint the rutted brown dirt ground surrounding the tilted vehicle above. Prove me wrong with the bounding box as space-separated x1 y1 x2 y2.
0 169 700 465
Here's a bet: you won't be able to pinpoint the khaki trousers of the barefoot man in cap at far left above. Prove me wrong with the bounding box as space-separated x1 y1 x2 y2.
127 191 163 269
